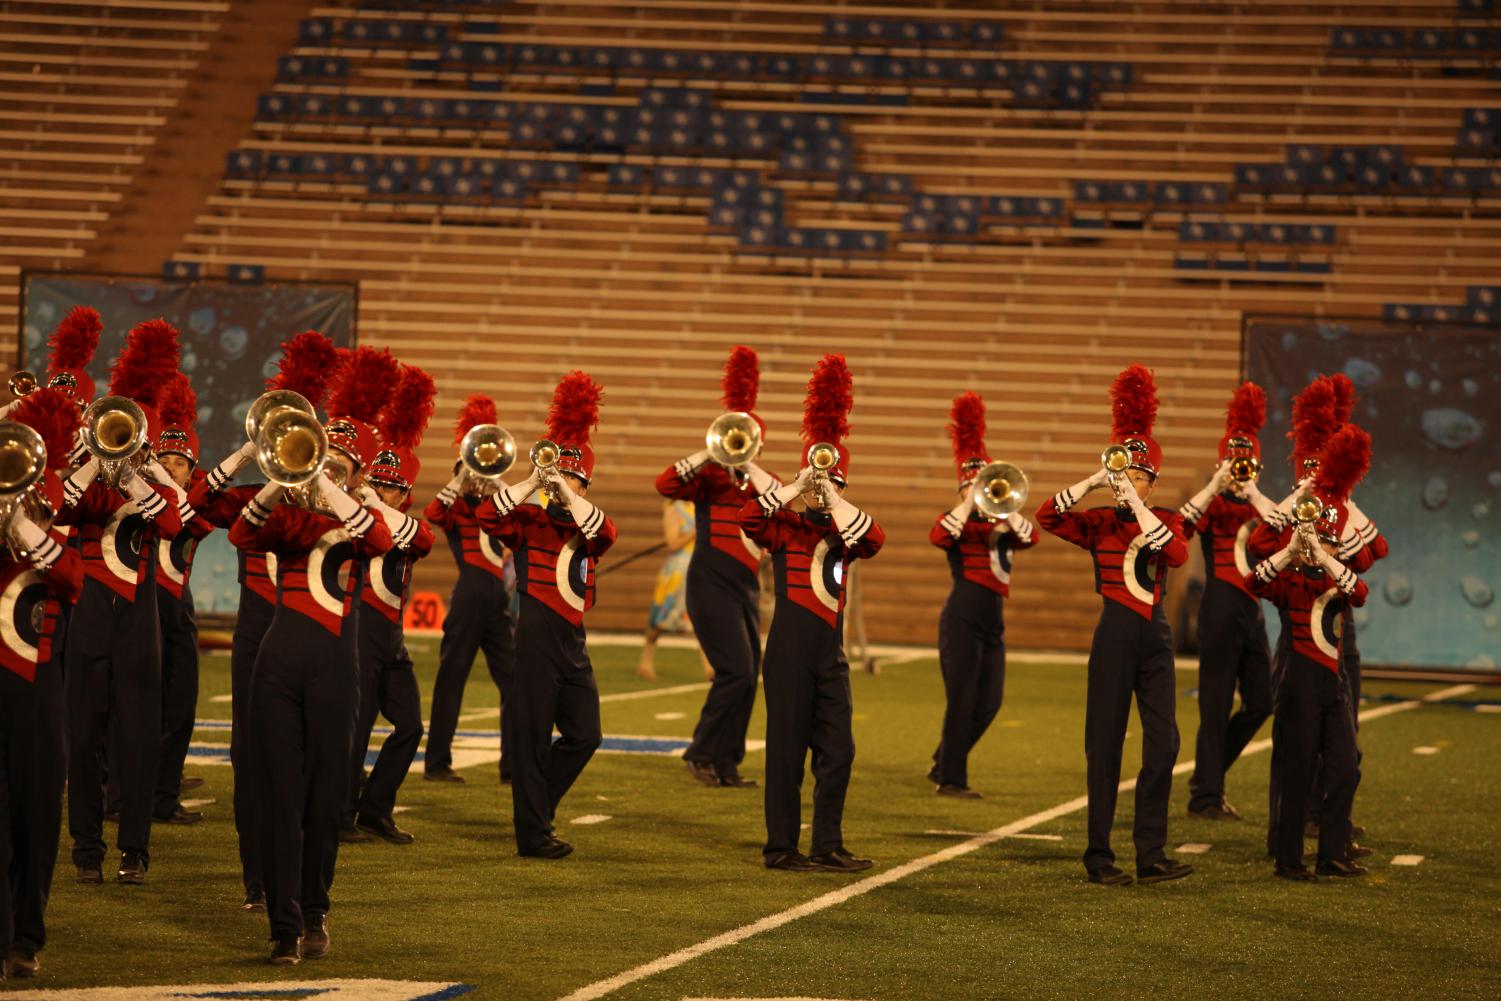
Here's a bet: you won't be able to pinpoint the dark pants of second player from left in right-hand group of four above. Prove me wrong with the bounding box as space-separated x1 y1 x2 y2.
1189 576 1271 810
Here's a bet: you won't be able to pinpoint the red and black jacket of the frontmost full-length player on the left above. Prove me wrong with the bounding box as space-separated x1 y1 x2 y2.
230 501 392 636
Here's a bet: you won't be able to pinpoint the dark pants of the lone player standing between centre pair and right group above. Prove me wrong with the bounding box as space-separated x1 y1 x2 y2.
934 581 1006 788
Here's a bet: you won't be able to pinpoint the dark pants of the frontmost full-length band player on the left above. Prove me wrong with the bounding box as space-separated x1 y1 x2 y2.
248 608 359 938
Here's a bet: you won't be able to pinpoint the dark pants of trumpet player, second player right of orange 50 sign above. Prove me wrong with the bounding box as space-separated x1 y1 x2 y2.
513 594 603 851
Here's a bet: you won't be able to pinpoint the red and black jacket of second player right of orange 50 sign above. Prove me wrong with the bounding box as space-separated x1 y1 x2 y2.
479 492 618 627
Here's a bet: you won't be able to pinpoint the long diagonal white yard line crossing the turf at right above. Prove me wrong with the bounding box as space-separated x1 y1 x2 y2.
561 684 1475 1001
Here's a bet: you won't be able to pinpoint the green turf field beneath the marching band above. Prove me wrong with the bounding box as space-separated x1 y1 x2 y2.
23 641 1501 999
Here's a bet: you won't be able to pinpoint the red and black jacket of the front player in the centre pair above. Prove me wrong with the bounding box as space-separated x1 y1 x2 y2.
740 494 886 629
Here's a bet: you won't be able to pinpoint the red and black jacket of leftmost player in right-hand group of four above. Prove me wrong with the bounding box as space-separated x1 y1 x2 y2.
1037 497 1189 618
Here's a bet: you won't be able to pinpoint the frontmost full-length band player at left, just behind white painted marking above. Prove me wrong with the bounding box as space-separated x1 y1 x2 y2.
230 348 396 965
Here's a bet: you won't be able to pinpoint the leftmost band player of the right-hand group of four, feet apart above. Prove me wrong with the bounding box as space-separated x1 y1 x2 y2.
1037 365 1193 885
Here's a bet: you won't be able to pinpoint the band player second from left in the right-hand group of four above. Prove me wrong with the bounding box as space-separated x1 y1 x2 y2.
1178 383 1273 821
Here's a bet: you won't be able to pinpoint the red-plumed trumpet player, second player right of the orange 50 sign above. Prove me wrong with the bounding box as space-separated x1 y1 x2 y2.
479 371 617 858
